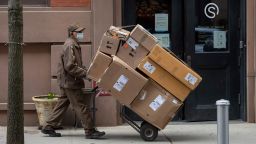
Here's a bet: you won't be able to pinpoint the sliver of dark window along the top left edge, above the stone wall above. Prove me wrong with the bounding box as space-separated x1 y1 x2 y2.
0 0 49 6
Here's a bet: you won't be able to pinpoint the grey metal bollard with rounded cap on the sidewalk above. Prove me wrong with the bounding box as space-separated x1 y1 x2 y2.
216 99 230 144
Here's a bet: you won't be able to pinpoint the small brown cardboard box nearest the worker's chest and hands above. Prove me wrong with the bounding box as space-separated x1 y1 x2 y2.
87 51 112 81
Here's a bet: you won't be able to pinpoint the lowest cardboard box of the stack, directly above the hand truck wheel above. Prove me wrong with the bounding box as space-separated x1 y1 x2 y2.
130 80 182 129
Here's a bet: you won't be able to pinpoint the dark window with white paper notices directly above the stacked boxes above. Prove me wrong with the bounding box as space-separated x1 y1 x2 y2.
135 0 171 49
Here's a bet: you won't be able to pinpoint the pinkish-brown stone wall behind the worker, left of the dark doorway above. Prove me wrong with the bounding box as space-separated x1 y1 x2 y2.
0 0 123 125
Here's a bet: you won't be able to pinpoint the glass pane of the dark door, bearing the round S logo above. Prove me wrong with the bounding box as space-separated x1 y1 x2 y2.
195 0 229 53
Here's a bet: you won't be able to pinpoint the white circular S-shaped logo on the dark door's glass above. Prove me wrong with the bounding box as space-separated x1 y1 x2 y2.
204 3 219 19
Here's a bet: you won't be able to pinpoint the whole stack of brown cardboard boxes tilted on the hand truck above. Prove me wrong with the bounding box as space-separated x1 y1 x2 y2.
87 25 202 129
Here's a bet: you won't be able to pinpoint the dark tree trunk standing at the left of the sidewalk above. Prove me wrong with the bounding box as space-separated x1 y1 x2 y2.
7 0 24 144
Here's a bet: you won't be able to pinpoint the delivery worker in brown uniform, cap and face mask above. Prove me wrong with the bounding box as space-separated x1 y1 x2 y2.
41 24 105 139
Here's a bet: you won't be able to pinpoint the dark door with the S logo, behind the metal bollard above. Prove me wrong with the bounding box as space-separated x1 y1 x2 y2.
184 0 240 121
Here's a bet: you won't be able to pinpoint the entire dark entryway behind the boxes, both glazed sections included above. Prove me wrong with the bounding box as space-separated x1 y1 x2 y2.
123 0 245 121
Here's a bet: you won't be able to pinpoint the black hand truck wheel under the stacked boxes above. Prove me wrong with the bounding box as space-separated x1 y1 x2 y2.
140 121 158 141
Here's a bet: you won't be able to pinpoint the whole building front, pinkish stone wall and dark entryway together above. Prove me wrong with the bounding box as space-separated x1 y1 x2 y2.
0 0 256 125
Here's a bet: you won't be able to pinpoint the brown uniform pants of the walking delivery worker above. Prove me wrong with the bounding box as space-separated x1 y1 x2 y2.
44 88 93 130
